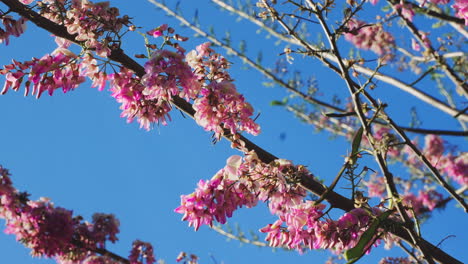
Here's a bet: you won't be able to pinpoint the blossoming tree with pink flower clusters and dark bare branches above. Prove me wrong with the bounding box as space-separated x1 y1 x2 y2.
0 0 468 264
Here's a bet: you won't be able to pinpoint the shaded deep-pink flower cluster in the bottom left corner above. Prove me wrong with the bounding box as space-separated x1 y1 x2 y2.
0 166 155 264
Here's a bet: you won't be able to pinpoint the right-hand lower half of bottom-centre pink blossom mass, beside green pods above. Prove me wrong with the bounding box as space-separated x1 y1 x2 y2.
260 201 381 254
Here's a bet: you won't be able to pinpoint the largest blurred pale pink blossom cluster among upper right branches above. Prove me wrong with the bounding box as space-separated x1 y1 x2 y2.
344 19 395 59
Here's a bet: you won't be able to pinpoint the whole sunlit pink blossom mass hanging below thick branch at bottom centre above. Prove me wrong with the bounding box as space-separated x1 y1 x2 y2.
175 153 392 253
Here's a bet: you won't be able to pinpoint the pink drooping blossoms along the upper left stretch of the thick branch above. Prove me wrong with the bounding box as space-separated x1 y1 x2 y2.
0 0 260 138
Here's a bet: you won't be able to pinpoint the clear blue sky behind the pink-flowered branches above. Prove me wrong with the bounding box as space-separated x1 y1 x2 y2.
0 0 468 264
